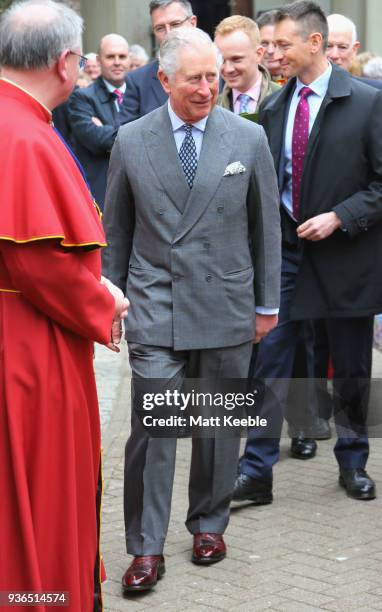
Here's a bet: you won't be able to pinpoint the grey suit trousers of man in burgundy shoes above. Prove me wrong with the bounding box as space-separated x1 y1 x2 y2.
124 342 252 555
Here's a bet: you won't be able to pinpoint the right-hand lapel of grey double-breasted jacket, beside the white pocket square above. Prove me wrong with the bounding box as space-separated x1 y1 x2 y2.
175 107 235 241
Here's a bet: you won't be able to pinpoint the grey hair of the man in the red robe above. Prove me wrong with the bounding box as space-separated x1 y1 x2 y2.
0 0 83 70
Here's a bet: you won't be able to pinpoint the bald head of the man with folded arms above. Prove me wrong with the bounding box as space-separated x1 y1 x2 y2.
98 34 129 87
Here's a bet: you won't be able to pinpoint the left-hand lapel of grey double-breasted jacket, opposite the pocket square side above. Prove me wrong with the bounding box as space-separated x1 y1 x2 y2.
143 104 190 213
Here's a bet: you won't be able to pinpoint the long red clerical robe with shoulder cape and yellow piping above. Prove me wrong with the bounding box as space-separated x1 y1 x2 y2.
0 80 114 612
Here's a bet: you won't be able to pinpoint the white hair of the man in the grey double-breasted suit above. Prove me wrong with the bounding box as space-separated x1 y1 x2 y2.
159 28 222 78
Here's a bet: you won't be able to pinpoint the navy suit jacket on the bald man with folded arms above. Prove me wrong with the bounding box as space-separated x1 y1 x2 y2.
69 77 120 209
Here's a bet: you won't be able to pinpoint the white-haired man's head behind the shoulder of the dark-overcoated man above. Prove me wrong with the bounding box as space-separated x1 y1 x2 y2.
326 13 360 70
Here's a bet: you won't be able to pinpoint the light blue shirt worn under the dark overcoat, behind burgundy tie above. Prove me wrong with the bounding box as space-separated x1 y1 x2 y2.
281 64 332 217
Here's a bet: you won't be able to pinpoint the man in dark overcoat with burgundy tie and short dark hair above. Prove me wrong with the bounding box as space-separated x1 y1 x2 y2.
234 0 382 502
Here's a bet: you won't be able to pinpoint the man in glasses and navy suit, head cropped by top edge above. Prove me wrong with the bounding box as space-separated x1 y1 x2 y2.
120 0 196 124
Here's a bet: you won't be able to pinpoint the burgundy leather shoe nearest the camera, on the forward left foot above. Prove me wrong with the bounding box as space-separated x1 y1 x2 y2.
122 555 166 593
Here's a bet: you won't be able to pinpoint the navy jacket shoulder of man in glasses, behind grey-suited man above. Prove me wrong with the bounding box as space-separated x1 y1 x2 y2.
120 60 168 124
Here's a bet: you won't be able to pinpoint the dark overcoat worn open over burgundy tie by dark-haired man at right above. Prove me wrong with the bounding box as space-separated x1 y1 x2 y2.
260 66 382 319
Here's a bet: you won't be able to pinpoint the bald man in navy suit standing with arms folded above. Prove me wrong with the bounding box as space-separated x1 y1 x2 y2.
69 34 129 209
